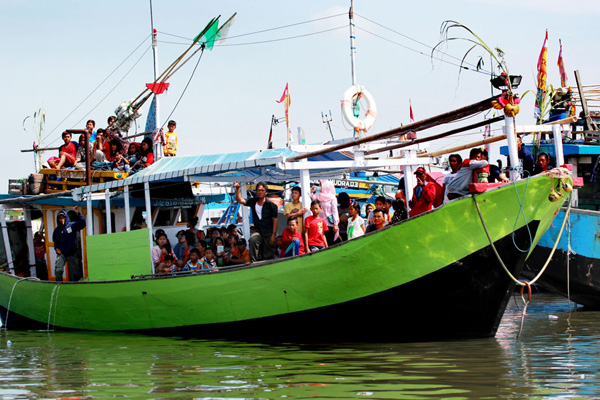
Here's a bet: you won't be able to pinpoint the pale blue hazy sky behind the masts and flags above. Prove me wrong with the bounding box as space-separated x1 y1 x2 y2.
0 0 600 192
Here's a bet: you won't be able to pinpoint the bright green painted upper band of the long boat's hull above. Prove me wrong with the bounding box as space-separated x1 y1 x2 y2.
0 176 559 330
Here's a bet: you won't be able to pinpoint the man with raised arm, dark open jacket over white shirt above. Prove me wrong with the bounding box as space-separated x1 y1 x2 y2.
233 182 277 262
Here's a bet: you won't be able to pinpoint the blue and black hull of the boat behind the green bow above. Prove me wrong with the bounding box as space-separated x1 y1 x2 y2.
522 209 600 309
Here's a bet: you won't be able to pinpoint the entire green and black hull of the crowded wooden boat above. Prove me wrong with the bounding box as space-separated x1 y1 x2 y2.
0 177 556 341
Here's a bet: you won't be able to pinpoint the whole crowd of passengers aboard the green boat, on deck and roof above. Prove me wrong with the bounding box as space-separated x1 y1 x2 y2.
54 134 552 280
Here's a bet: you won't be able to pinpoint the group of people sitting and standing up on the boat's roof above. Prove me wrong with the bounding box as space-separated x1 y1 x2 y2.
48 116 177 174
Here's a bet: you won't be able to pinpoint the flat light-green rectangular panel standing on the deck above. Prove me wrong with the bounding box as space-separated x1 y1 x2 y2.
86 229 152 281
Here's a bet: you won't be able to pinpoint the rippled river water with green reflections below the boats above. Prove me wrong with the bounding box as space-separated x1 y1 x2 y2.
0 294 600 399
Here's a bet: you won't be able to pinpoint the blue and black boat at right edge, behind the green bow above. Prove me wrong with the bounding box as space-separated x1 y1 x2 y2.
501 130 600 309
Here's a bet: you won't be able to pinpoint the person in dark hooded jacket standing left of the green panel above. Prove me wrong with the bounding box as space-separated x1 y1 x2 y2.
52 206 85 282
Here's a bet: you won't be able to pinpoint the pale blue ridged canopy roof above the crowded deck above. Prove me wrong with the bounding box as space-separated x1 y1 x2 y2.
73 146 354 196
